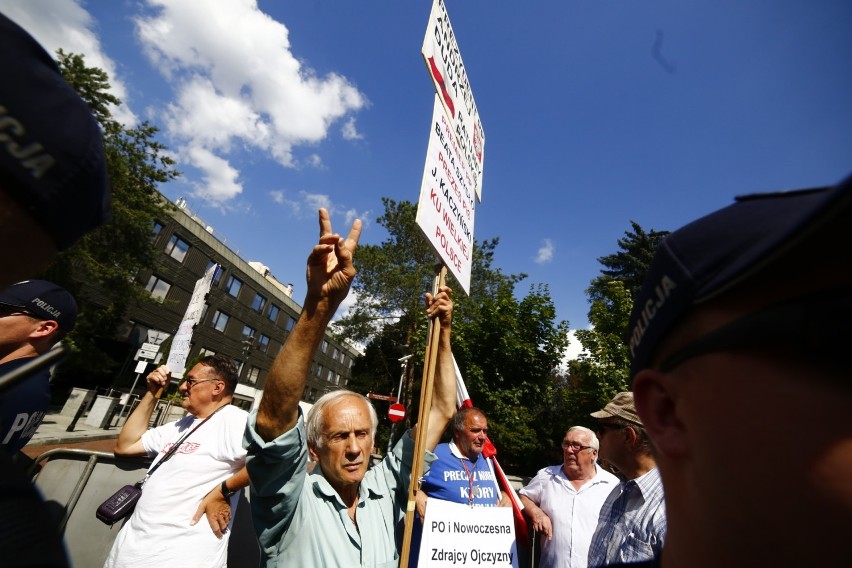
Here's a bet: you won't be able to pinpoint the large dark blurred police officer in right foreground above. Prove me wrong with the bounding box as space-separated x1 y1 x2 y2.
629 178 852 568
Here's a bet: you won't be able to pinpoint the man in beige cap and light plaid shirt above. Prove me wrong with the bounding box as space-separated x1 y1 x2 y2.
589 392 666 568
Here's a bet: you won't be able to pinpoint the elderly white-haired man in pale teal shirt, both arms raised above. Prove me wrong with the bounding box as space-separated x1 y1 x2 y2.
246 209 456 567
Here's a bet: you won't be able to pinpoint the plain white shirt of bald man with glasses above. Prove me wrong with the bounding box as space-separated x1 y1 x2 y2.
521 464 618 568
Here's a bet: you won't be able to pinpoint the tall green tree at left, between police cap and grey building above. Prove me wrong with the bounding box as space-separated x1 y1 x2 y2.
41 50 179 392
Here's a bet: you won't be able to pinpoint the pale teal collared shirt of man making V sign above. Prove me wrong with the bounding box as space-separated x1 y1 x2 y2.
245 409 435 568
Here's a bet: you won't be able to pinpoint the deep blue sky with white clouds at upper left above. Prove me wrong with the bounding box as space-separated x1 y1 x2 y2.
0 0 852 350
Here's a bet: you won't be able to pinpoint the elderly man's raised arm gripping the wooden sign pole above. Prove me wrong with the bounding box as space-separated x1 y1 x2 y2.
424 286 456 452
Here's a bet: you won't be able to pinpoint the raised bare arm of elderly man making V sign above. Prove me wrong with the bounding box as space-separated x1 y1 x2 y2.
256 209 361 442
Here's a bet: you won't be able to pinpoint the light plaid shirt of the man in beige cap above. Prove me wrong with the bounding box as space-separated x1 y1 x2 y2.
589 468 666 567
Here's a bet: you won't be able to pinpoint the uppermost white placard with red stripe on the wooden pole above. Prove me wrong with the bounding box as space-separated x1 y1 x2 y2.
420 0 485 201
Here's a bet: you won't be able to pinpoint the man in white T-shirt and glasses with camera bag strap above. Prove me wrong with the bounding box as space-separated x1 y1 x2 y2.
104 355 249 568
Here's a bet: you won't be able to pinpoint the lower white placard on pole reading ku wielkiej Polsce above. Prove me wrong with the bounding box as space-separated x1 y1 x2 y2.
416 96 475 294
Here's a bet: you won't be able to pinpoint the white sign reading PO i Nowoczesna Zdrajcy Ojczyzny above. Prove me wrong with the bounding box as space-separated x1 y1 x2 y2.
417 499 518 568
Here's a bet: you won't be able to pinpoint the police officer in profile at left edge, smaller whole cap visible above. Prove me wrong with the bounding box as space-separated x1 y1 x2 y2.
0 280 77 455
